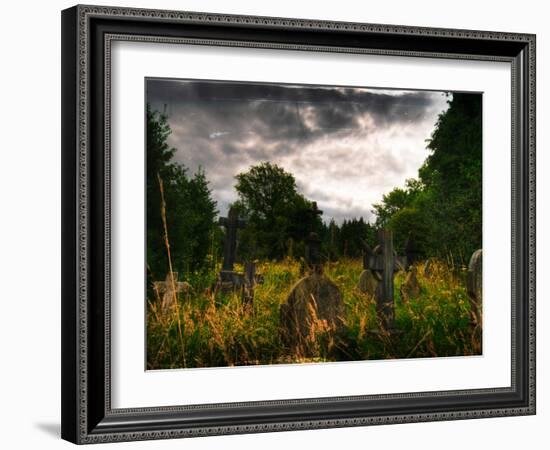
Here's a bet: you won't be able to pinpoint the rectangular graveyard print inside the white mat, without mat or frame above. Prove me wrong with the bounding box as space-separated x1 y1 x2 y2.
146 78 483 370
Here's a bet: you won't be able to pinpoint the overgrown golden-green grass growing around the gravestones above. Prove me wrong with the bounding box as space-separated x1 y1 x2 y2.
147 259 480 369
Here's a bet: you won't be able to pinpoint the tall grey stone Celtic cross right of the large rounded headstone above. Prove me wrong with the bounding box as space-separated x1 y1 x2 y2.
364 229 407 331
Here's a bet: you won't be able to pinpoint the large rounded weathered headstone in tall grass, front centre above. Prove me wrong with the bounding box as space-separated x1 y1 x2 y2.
279 272 344 356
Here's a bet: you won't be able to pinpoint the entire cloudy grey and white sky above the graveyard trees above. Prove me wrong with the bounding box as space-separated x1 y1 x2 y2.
146 79 448 223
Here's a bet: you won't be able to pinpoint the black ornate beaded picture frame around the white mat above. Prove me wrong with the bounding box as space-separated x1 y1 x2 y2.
62 6 535 443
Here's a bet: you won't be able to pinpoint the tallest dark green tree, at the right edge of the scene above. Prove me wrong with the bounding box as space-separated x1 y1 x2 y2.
419 94 482 261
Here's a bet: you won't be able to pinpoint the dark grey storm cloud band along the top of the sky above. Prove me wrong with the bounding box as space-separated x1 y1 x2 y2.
147 79 442 140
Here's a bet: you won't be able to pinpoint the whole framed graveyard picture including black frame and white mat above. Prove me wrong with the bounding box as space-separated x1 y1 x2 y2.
62 6 535 444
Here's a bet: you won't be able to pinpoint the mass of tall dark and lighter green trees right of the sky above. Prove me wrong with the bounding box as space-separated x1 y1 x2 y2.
373 93 482 263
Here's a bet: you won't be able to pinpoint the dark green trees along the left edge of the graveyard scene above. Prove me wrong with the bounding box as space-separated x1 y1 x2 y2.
146 105 219 280
